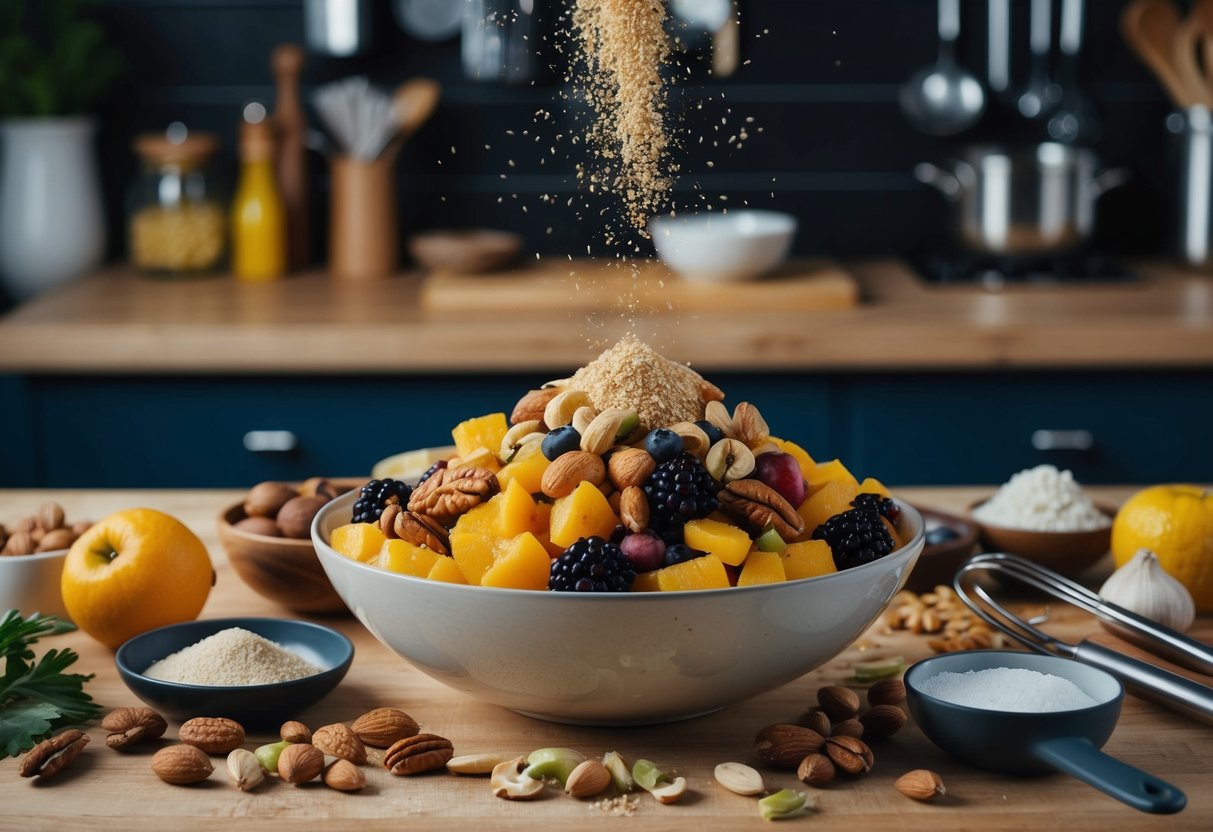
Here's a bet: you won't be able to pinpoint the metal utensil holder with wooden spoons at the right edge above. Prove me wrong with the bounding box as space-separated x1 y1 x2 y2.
1167 104 1213 266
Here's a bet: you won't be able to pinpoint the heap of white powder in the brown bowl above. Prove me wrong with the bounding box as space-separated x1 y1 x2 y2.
973 465 1112 531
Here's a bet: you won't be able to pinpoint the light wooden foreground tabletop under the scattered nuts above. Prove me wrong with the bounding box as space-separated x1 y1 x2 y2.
0 489 1213 832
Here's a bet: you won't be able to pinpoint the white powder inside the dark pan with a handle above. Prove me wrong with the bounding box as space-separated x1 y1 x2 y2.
918 667 1098 713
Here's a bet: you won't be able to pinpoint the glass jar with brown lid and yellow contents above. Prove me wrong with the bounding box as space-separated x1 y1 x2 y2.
129 121 227 277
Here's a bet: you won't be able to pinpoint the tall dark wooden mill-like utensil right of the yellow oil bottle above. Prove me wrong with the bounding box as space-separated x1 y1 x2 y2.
269 44 309 270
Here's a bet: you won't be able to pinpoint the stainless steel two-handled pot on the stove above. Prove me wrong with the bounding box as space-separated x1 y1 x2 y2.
915 142 1128 255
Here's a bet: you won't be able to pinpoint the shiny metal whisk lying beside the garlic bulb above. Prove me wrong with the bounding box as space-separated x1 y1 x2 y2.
952 553 1213 724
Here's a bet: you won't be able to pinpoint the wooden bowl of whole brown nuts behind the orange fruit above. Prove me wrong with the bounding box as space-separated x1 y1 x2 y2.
217 477 365 612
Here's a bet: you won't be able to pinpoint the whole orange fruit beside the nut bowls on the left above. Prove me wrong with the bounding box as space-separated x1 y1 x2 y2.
59 508 215 648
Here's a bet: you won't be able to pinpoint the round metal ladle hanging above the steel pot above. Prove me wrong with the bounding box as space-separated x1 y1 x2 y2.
898 0 985 136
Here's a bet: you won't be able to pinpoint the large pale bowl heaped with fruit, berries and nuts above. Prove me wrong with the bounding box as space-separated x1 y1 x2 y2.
312 340 923 724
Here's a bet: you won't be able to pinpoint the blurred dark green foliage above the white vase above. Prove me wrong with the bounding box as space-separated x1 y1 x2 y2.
0 0 124 116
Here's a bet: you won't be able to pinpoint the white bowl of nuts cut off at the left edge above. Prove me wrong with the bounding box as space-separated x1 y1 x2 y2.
0 502 92 619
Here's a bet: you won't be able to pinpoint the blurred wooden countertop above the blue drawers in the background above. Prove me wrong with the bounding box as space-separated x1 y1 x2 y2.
0 261 1213 374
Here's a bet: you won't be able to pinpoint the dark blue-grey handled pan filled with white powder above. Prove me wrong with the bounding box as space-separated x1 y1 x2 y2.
905 650 1188 814
